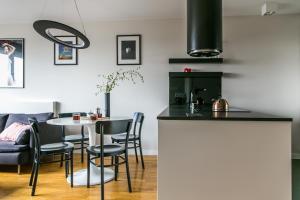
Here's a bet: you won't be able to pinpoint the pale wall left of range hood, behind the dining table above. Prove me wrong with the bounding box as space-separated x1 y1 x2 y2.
0 21 184 154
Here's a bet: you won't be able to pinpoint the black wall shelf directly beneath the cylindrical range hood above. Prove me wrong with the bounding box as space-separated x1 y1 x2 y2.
169 58 223 64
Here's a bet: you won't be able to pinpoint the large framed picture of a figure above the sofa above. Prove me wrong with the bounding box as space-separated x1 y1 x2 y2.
0 38 24 88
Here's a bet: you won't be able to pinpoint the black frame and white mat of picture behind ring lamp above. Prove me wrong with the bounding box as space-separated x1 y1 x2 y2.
53 35 78 65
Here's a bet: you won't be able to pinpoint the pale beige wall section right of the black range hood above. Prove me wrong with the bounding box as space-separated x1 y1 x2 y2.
172 15 300 152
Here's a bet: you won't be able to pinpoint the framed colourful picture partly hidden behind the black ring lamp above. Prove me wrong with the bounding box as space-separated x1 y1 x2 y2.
54 36 78 65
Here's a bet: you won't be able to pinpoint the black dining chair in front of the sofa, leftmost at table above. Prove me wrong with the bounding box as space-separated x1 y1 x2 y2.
28 118 74 196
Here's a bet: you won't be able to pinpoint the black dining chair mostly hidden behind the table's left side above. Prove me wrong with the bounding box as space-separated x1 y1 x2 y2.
58 112 89 166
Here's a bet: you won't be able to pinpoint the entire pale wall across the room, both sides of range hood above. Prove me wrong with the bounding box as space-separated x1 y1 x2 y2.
0 16 300 154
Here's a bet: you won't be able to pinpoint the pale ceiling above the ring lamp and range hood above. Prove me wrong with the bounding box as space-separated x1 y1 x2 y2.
0 0 300 24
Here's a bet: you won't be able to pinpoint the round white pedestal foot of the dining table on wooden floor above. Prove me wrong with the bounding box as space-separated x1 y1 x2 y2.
67 164 115 186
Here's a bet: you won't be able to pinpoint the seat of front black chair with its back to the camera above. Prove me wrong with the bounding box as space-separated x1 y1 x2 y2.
86 144 125 156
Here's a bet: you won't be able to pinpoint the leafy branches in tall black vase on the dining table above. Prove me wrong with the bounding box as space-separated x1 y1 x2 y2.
96 67 144 117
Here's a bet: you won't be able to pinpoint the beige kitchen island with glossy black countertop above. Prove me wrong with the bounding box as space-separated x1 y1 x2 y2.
157 106 292 200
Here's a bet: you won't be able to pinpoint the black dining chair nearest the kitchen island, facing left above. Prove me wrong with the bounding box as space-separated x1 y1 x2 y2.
111 112 145 169
